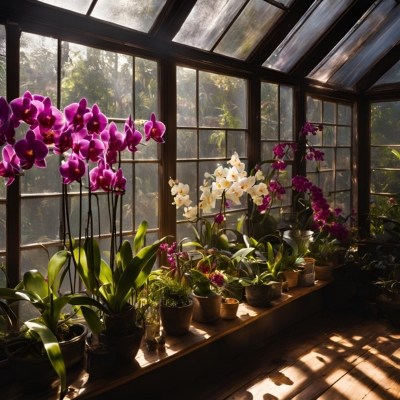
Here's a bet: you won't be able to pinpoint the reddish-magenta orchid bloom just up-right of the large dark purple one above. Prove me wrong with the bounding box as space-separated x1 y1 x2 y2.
37 97 65 145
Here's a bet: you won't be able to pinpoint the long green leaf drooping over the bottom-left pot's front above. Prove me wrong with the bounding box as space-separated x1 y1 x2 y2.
25 322 67 393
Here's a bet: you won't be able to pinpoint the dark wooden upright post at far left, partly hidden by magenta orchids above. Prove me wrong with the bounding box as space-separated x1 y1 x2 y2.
6 22 21 290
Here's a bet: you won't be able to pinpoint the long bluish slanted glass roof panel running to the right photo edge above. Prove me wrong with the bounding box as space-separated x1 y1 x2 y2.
328 4 400 89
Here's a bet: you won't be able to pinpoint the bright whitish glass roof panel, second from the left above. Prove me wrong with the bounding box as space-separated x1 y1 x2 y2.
90 0 167 33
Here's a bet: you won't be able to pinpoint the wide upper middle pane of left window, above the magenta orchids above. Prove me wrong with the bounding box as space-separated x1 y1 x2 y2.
61 42 133 119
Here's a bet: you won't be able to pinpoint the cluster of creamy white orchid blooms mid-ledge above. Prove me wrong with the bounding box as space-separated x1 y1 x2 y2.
168 152 269 219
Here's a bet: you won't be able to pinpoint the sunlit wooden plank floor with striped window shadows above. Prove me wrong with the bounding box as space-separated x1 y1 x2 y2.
189 312 400 400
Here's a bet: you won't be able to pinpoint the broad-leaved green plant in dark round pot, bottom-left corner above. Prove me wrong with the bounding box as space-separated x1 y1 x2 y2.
0 250 106 393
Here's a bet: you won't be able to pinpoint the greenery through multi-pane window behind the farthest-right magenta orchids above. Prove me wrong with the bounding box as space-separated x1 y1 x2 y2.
307 96 352 216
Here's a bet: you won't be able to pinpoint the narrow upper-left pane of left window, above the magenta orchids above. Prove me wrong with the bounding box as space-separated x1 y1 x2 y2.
20 32 57 105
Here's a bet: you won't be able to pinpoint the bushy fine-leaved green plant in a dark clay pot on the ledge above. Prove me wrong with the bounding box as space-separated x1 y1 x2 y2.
148 270 193 336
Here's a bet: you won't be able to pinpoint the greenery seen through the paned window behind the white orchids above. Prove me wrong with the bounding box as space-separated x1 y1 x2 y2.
176 67 247 240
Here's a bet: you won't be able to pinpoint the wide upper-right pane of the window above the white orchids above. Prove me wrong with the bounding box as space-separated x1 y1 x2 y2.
199 71 247 128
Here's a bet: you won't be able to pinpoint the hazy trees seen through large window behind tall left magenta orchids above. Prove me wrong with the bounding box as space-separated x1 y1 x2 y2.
17 32 160 308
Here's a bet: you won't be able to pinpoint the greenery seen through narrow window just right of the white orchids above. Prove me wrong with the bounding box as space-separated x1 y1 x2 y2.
261 82 295 223
